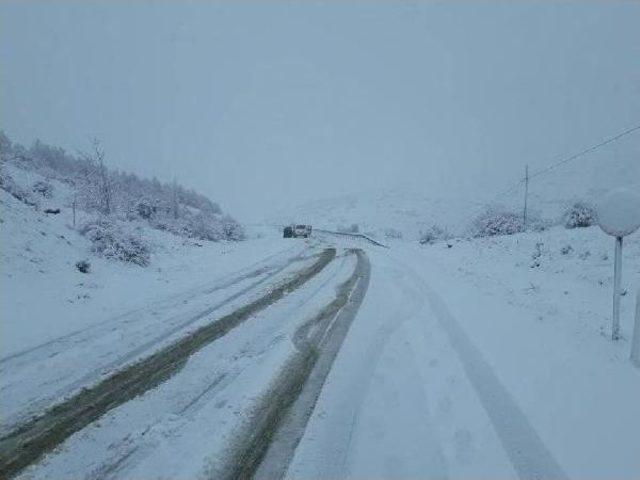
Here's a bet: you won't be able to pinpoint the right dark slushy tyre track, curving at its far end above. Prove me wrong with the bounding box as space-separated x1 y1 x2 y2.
215 250 370 479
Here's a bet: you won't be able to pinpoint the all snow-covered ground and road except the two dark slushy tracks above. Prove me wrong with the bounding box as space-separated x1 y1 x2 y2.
0 162 640 479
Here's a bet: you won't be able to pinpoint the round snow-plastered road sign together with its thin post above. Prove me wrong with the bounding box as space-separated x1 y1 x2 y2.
598 188 640 340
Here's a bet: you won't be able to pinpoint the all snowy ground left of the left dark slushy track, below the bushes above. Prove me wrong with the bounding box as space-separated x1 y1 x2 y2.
0 162 318 432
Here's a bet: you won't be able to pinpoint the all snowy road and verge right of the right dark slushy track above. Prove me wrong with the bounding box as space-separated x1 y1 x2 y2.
288 227 640 479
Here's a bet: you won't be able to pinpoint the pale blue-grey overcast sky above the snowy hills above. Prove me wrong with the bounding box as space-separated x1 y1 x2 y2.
0 1 640 219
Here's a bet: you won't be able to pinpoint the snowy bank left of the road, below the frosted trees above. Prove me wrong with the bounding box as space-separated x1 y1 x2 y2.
0 165 296 357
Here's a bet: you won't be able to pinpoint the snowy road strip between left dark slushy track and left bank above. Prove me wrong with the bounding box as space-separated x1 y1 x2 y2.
0 246 316 434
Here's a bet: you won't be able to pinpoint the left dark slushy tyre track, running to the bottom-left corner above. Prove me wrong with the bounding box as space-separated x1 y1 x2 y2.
0 249 336 478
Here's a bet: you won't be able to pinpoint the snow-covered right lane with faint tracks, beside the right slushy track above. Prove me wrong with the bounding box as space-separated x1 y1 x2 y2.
288 251 566 479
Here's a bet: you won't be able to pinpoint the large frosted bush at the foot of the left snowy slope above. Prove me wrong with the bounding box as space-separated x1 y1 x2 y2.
80 218 151 267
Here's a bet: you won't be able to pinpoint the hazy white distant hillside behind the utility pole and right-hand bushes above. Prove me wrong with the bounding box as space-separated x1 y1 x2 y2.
270 138 640 240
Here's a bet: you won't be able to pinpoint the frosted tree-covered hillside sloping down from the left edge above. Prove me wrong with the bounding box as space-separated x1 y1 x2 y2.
0 131 244 241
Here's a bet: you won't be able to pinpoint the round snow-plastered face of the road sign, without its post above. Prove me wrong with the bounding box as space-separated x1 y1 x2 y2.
598 188 640 237
